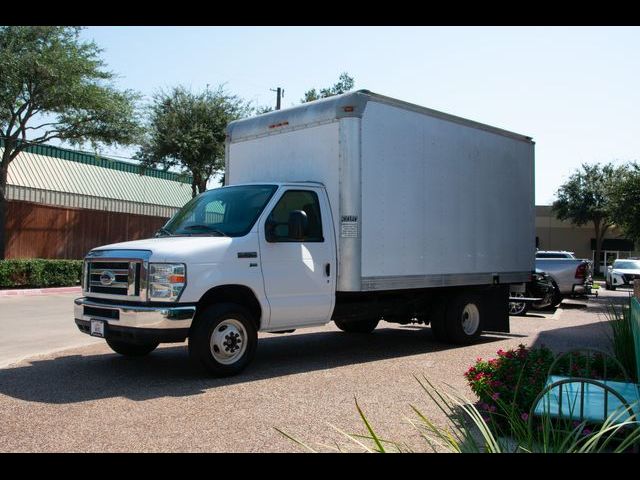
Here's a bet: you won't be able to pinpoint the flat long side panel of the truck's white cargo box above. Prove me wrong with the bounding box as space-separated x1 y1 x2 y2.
361 101 535 290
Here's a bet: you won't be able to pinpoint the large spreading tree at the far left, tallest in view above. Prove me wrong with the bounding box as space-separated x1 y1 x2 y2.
0 26 139 258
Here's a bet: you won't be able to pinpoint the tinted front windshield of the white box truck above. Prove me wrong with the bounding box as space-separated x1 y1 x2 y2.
158 185 278 237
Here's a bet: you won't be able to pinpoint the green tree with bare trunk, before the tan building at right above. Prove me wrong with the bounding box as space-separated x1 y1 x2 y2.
553 163 626 273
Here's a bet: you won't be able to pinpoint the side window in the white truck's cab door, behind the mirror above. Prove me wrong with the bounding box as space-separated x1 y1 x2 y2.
265 190 324 242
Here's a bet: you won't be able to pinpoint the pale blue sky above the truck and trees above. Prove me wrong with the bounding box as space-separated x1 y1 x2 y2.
71 26 640 205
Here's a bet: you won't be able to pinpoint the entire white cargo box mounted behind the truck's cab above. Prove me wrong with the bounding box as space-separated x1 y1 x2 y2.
226 92 535 292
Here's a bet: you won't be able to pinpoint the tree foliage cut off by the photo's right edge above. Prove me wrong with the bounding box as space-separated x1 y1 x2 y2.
611 162 640 244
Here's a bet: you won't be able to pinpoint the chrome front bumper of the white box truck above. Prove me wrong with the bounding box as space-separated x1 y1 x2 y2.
74 297 196 342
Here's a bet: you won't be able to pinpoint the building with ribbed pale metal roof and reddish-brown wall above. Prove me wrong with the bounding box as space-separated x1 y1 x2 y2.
0 139 191 259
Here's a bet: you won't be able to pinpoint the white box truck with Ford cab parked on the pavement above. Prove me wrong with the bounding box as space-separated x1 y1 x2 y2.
75 90 535 376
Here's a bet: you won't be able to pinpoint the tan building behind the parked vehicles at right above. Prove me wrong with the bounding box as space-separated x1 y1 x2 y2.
536 205 640 272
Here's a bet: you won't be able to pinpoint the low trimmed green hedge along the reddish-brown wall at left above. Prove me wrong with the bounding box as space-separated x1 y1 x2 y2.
0 258 82 288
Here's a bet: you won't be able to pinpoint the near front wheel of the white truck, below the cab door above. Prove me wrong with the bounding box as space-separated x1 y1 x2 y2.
189 303 258 377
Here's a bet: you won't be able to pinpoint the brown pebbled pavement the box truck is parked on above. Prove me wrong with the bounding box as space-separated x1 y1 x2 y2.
0 290 628 452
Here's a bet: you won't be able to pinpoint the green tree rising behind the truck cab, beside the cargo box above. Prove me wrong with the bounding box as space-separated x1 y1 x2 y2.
136 86 253 197
